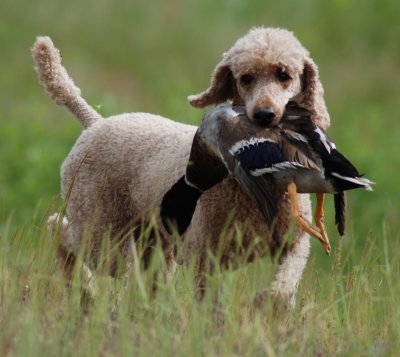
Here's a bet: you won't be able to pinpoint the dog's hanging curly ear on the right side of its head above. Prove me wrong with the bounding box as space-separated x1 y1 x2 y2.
300 58 330 129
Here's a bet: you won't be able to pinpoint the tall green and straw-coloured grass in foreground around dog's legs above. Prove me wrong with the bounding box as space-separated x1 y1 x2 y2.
0 216 400 356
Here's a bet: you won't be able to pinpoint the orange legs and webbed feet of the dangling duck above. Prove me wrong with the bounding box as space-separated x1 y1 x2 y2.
288 182 331 255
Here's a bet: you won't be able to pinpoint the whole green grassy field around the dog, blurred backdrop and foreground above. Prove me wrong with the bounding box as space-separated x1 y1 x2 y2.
0 0 400 356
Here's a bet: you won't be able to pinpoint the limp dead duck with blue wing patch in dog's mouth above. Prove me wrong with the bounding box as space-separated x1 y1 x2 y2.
160 101 374 255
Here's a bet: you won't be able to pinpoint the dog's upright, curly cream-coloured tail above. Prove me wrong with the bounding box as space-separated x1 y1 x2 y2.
32 37 103 129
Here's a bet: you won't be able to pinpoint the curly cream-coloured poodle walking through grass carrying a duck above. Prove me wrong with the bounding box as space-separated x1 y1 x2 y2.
32 28 329 308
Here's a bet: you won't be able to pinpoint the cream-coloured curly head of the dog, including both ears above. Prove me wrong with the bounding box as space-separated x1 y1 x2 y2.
188 28 329 128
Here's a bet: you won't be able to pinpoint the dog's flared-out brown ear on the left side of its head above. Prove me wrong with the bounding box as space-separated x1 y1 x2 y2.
188 59 237 108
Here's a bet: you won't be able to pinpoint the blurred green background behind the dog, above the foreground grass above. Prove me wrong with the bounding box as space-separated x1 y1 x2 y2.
0 0 400 254
